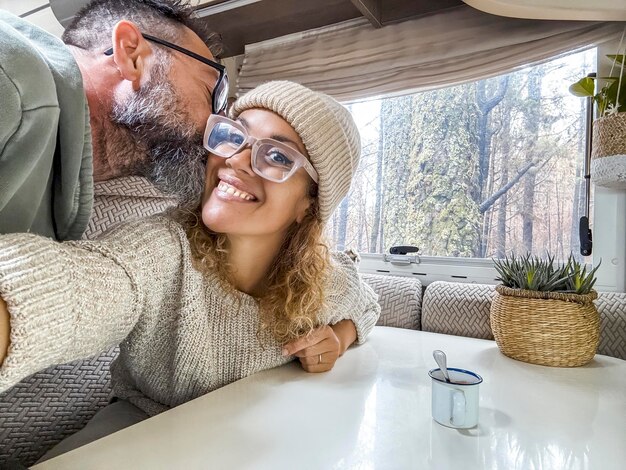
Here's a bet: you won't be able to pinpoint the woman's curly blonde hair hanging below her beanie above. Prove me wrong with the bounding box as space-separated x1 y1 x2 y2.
176 184 331 344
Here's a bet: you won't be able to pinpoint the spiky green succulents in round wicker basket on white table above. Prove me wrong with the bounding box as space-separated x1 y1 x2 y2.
490 254 600 367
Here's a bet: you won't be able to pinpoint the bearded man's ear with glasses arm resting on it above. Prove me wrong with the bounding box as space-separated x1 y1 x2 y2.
112 20 152 91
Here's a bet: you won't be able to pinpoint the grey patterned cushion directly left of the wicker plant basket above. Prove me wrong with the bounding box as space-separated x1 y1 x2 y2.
422 281 495 339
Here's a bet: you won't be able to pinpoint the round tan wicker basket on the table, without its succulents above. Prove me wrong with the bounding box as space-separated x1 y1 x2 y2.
491 285 600 367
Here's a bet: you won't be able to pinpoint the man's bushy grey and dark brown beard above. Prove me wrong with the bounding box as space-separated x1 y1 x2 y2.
107 60 207 208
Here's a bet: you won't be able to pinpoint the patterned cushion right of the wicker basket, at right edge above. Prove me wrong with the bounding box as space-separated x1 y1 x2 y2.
595 292 626 359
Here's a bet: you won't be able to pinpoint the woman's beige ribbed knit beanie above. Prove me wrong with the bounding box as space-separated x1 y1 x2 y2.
230 81 361 222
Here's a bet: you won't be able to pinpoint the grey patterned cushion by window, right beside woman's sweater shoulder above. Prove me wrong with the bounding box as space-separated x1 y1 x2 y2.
361 274 422 330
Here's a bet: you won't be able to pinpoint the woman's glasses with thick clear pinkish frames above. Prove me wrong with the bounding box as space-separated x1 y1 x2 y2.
204 115 318 183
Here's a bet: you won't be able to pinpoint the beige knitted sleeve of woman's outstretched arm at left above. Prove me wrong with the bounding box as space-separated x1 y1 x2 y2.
0 218 184 392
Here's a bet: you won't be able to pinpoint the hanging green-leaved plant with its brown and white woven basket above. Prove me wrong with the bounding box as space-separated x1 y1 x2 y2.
569 54 626 189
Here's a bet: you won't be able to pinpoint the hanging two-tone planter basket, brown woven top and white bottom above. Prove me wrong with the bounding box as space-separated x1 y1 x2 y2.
591 112 626 189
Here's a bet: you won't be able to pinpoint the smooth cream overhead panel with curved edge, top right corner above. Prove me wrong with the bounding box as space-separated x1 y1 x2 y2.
463 0 626 21
